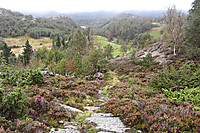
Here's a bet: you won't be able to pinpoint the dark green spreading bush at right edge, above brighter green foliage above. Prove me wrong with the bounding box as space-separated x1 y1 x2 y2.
151 63 200 91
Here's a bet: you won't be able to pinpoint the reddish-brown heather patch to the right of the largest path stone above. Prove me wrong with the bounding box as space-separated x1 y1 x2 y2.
104 97 200 132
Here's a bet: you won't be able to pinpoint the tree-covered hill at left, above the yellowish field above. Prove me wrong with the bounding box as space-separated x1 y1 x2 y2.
0 8 79 38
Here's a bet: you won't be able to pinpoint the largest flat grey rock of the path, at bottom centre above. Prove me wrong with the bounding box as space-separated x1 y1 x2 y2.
86 113 130 133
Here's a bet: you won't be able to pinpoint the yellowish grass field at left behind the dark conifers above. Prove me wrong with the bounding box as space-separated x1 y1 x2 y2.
3 36 52 54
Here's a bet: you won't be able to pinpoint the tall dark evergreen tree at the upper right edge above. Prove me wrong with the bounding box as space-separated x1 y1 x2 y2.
186 0 200 49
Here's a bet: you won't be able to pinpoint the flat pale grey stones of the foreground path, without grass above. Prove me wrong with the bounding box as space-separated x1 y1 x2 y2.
50 90 139 133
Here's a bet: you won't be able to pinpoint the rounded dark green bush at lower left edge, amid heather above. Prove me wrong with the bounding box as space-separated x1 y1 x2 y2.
0 88 29 120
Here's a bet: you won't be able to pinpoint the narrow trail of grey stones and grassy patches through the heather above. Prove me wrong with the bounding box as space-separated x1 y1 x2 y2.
51 72 138 133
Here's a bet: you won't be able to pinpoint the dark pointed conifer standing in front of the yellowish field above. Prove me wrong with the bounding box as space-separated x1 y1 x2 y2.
22 40 33 66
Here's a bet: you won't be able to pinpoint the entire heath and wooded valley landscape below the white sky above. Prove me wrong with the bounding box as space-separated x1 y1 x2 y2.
0 0 200 133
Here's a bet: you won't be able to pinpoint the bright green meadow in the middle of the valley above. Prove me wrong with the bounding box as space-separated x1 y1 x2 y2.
93 36 123 57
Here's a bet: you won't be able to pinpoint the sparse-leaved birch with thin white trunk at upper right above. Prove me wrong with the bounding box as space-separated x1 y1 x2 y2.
164 6 185 55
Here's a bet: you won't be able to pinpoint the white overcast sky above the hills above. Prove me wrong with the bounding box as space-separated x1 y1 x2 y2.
0 0 194 13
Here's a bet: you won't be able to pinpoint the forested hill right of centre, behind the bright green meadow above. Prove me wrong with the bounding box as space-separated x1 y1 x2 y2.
98 14 151 41
